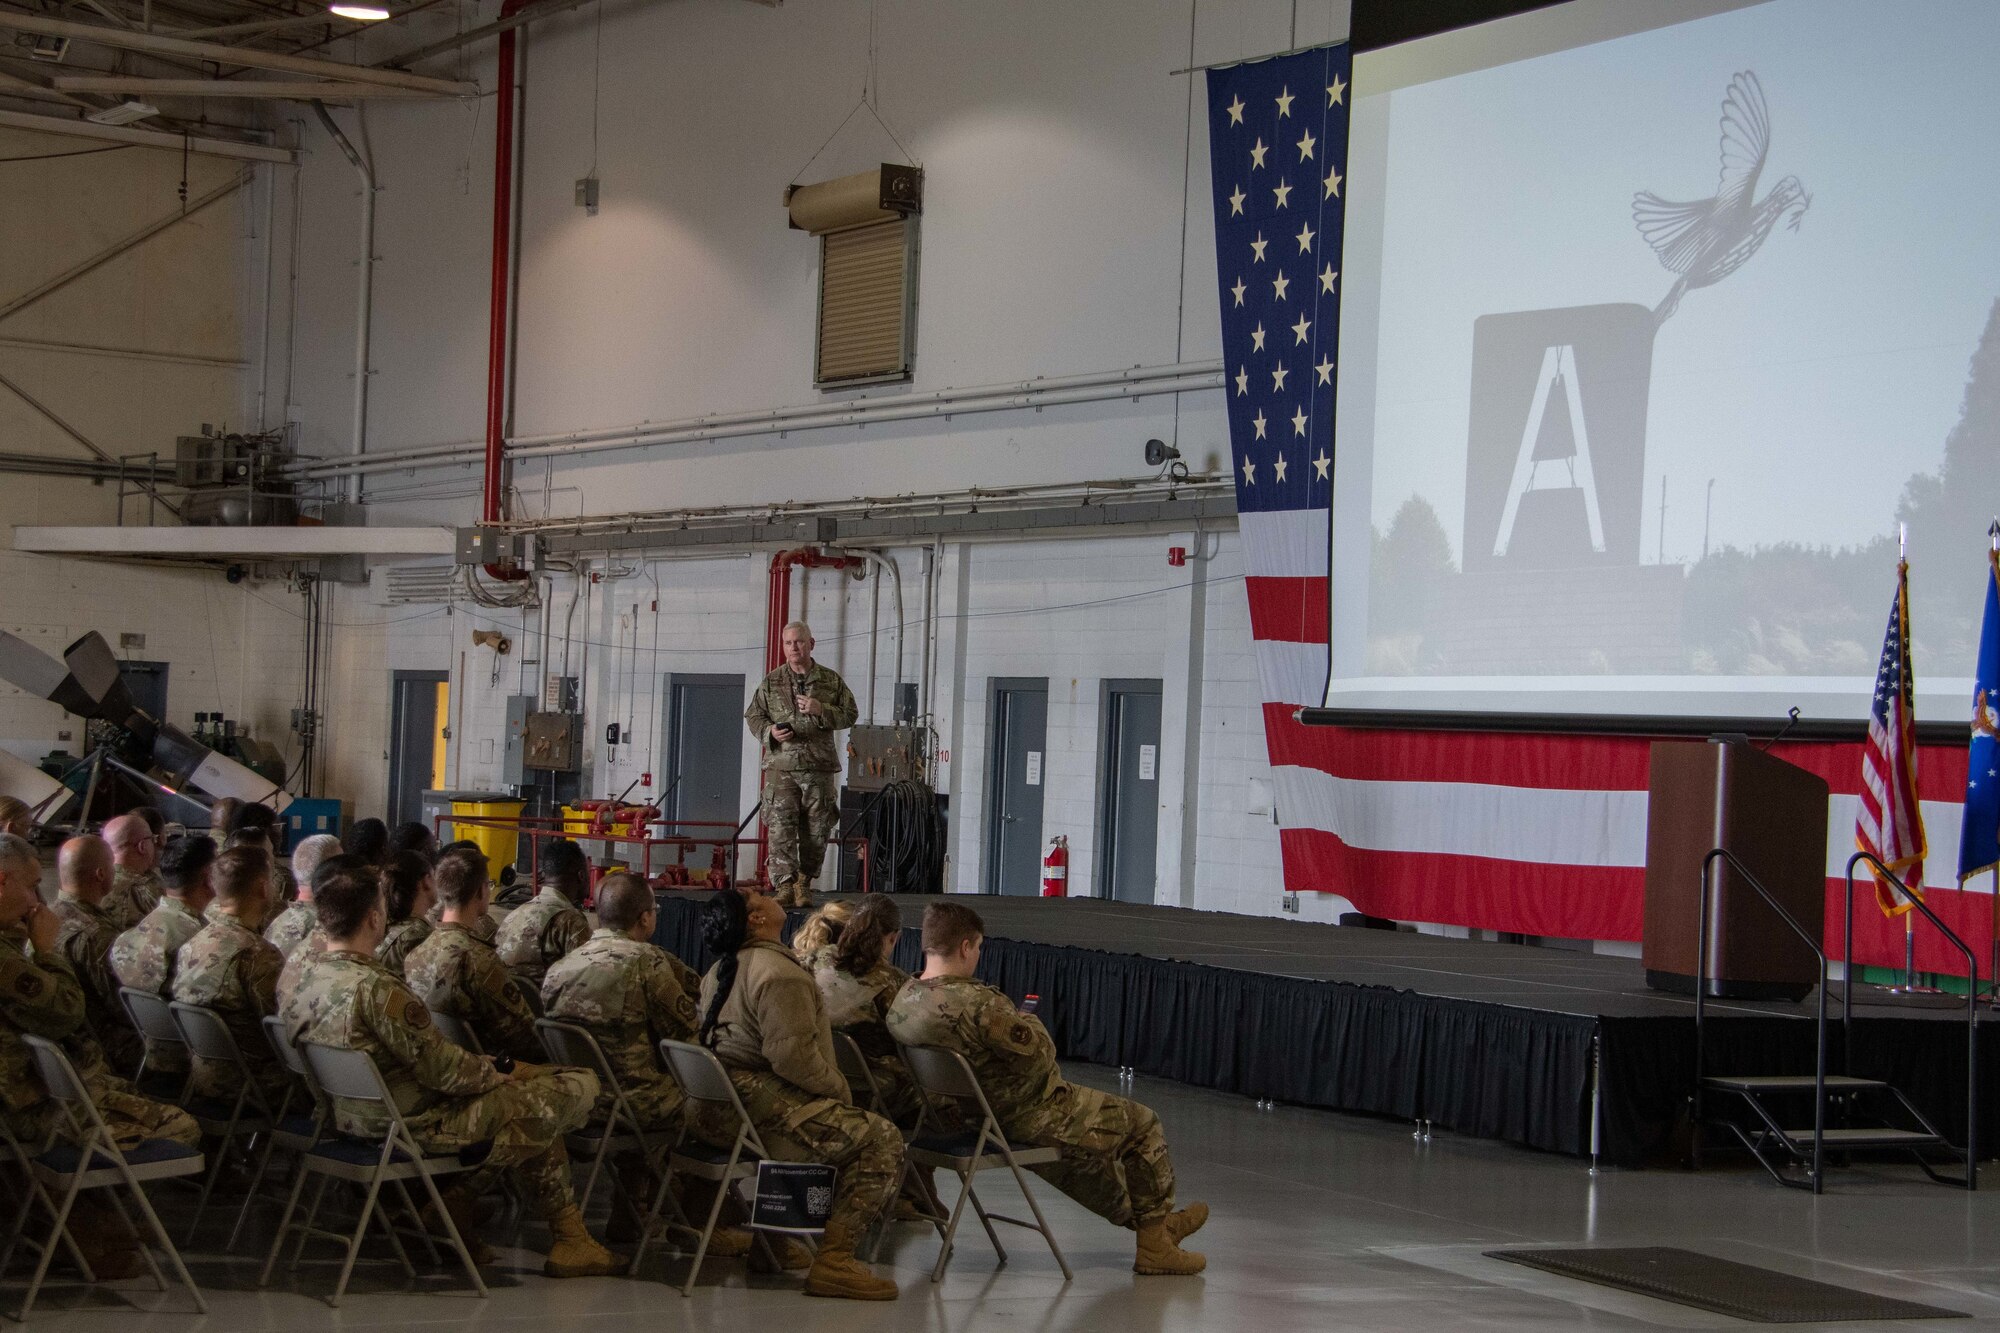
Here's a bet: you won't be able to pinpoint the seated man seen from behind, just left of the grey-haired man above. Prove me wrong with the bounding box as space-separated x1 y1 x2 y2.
174 847 290 1109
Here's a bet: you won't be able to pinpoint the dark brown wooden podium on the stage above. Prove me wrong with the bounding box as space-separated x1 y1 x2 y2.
1644 741 1826 1001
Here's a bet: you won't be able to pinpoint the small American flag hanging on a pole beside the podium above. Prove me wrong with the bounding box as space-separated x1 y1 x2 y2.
1854 562 1924 917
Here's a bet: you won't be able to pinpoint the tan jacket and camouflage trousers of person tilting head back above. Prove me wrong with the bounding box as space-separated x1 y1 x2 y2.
688 941 902 1235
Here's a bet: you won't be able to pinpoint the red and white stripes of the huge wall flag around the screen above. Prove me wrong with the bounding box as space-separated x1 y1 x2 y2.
1240 510 1992 973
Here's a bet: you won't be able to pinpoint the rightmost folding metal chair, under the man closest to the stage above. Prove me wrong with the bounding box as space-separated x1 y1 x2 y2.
902 1047 1072 1283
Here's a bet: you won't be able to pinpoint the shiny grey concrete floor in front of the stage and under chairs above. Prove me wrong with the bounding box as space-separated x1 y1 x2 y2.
0 1065 2000 1333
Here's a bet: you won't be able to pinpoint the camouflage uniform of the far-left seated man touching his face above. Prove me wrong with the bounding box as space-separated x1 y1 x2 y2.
0 925 202 1149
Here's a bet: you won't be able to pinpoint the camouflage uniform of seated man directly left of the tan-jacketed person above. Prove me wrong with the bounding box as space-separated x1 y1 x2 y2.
542 929 702 1131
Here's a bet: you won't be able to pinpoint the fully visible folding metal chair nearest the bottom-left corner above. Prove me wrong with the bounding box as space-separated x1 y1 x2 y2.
16 1033 208 1323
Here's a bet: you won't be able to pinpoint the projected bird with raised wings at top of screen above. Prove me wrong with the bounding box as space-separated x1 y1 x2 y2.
1632 70 1812 322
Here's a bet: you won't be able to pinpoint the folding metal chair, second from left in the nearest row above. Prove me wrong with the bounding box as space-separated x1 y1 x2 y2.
258 1041 486 1309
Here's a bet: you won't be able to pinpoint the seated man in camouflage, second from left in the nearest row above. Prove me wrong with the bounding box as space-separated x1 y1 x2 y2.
284 852 622 1277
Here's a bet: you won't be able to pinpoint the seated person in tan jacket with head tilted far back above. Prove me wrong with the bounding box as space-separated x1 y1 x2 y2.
688 891 902 1301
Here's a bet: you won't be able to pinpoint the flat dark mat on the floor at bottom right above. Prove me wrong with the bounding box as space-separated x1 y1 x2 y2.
1486 1245 1970 1323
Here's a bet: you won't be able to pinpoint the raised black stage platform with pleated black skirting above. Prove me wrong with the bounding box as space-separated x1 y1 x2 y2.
656 893 2000 1165
